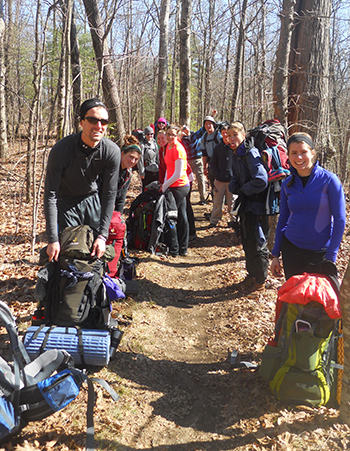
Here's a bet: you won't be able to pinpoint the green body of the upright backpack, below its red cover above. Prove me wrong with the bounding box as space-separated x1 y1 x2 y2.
259 301 337 407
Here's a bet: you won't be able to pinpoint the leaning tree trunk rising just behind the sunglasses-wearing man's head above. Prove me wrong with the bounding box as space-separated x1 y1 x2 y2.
84 0 125 144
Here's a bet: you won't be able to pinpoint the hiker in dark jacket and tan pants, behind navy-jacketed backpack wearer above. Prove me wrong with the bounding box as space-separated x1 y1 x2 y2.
209 125 237 227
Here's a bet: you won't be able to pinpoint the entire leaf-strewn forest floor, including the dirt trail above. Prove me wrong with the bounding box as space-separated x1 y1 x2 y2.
0 151 350 451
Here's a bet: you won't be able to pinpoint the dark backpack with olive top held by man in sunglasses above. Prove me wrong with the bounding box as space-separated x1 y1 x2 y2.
35 225 111 329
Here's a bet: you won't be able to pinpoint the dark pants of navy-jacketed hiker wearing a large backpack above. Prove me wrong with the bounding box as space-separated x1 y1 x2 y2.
240 211 269 283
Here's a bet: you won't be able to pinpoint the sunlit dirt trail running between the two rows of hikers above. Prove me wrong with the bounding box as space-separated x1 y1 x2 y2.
108 196 288 450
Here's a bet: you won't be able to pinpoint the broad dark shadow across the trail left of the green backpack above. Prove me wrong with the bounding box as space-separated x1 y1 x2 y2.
110 352 277 436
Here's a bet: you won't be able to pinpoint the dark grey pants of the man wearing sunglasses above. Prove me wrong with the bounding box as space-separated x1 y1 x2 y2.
57 193 101 236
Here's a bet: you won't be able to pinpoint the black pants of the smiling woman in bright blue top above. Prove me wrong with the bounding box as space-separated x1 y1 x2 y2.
281 236 326 280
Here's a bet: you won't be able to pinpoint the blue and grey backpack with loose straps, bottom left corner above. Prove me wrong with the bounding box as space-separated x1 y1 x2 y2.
0 301 119 450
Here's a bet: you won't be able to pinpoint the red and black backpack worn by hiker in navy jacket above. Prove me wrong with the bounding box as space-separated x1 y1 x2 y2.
248 119 290 216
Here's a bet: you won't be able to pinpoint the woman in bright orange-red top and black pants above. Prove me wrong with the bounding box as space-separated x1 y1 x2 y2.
161 125 190 256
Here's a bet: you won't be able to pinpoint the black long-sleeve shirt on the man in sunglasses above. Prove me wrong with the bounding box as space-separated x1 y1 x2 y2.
44 133 120 243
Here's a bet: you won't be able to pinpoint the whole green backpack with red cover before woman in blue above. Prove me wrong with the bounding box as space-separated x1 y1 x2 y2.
259 273 340 407
